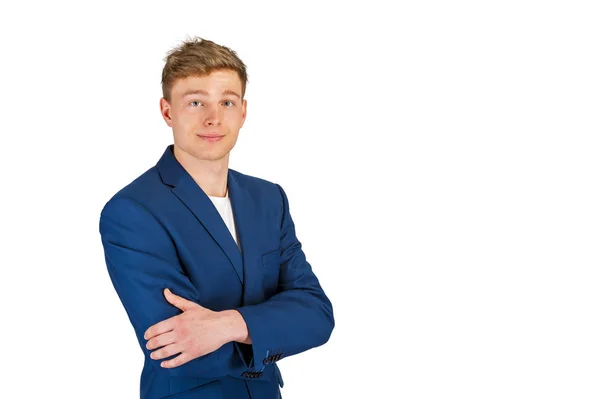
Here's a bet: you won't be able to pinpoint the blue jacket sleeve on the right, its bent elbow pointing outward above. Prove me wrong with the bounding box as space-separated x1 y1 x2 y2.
236 184 335 371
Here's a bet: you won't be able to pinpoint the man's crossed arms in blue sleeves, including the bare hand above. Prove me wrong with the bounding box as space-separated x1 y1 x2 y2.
100 185 334 377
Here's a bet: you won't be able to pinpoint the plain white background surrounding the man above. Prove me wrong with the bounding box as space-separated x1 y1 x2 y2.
0 0 600 399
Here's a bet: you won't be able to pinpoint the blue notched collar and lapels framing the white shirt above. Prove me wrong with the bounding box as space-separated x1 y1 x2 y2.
156 145 249 284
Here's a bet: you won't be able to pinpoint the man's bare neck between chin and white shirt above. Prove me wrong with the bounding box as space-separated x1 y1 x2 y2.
173 145 229 197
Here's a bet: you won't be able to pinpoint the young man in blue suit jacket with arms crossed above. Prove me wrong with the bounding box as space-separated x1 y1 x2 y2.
100 38 334 399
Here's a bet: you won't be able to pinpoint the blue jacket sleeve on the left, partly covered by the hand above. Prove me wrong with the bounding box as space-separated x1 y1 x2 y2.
100 197 233 377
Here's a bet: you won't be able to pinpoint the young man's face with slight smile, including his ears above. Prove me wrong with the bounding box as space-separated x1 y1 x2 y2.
160 70 246 161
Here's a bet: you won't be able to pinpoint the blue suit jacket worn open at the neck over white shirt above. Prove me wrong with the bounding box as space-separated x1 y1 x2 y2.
100 145 334 399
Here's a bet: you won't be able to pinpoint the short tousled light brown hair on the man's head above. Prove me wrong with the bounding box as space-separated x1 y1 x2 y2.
161 37 248 102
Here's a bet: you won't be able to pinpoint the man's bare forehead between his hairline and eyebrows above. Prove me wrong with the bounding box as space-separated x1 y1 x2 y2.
173 70 242 95
